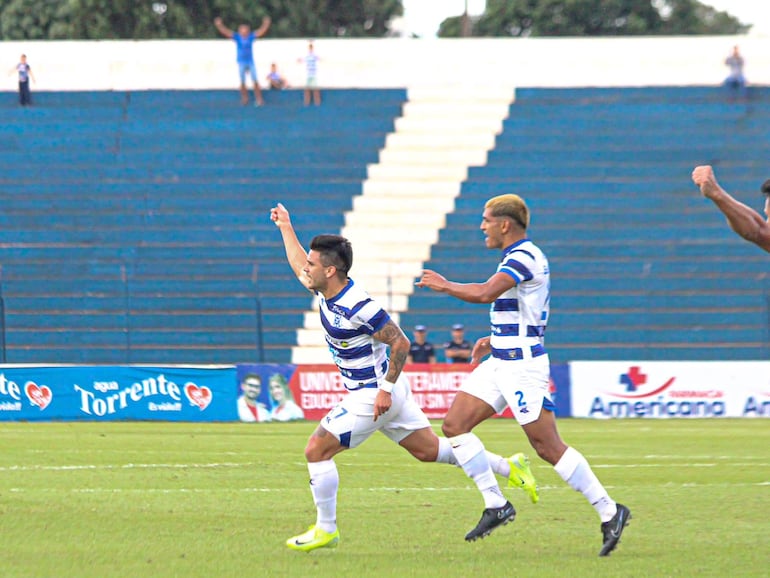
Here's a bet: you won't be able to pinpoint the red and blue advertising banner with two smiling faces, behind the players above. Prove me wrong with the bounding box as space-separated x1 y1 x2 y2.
237 363 570 422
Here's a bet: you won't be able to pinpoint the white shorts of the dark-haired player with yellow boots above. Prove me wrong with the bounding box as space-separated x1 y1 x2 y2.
320 374 430 448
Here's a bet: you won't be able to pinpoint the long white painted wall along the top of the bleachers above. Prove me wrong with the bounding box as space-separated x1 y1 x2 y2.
0 36 770 90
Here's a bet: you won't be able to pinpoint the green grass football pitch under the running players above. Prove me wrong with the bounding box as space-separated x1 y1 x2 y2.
0 420 770 578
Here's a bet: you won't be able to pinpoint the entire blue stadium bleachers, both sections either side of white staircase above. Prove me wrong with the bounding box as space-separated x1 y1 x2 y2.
0 87 770 363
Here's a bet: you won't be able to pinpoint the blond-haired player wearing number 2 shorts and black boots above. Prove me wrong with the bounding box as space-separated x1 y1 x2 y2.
417 194 631 556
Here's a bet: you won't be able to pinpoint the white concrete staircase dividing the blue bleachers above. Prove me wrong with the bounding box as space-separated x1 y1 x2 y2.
292 86 514 363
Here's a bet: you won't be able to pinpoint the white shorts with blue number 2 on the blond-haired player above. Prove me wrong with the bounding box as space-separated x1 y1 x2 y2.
460 355 555 425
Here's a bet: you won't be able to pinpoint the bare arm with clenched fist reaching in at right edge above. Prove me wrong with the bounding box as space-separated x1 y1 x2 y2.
692 165 770 252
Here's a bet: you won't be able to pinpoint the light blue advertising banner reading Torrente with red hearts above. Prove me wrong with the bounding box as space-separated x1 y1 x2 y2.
0 366 237 421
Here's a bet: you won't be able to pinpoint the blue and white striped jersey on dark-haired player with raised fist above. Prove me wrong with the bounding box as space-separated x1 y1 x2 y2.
317 279 390 390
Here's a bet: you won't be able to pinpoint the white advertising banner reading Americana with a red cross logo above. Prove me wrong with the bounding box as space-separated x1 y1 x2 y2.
570 361 770 418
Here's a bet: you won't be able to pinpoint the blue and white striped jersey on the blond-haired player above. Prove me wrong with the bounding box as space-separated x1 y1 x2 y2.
489 239 551 352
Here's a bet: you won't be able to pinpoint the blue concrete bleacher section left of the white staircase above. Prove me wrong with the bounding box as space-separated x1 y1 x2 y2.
0 90 406 363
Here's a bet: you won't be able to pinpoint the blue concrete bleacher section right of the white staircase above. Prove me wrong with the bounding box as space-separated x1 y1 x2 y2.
401 87 770 362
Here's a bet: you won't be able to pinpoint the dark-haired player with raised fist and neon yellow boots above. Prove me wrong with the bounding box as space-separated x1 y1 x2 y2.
270 203 537 552
